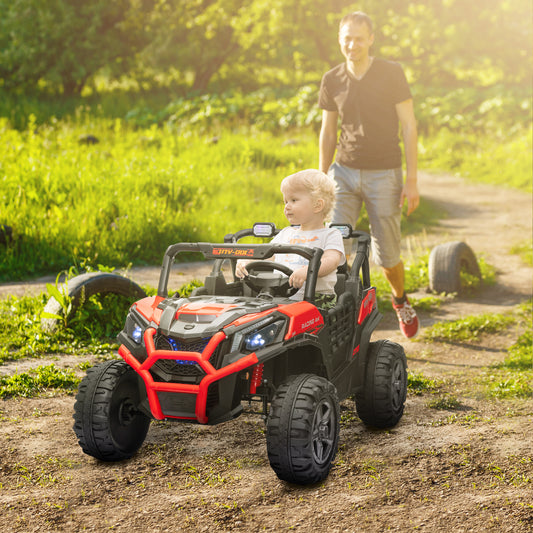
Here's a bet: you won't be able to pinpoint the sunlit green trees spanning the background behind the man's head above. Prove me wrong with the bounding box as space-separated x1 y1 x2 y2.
0 0 531 102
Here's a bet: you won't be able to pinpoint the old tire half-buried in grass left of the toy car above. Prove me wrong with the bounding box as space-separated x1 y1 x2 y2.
41 272 146 332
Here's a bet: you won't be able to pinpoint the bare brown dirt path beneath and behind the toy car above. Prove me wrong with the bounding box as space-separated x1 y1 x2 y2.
0 174 533 532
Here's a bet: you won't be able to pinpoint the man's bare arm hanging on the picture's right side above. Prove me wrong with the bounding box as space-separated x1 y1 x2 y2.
396 99 420 215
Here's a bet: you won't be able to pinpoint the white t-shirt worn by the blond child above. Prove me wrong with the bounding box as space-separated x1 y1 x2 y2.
271 226 346 300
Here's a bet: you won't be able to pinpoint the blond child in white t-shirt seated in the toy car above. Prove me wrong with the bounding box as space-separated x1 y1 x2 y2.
235 169 346 306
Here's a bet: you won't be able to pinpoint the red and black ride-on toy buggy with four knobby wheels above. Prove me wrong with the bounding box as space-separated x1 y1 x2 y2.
69 223 407 484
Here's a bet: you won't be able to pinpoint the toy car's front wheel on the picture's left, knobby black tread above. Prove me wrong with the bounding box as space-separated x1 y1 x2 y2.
73 360 150 461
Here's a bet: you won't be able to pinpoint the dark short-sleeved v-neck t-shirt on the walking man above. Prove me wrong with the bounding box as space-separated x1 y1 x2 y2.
318 58 412 169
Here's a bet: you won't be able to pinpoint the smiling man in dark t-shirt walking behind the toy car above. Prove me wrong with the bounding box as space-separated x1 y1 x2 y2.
319 11 419 338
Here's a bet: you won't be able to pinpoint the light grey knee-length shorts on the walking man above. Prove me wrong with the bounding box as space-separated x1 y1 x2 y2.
328 163 403 268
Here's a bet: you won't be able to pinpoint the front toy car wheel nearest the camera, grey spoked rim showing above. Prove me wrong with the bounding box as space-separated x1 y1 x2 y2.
266 374 340 485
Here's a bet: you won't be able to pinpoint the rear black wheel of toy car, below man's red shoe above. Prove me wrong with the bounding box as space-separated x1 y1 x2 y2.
355 340 407 429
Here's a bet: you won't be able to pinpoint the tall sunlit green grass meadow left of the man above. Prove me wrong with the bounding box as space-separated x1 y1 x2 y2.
0 116 317 280
